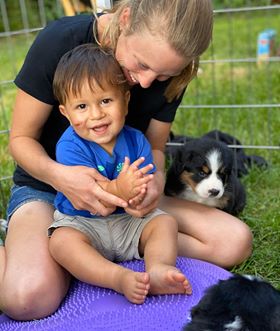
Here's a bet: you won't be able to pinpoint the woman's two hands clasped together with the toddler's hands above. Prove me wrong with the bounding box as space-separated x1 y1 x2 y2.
57 158 162 217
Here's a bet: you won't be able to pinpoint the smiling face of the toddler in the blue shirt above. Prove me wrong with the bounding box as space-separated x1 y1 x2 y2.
59 82 130 154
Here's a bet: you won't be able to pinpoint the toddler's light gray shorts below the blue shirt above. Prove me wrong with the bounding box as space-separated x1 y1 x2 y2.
48 209 166 262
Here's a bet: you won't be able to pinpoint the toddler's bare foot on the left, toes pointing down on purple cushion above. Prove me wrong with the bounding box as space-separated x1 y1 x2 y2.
115 269 150 304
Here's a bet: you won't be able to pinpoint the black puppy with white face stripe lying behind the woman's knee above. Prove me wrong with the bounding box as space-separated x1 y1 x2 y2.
165 137 246 215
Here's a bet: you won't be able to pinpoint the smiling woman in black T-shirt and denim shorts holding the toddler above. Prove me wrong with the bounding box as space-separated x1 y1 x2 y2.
0 0 252 320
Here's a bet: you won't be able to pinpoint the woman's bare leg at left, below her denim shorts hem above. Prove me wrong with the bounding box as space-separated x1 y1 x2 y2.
0 201 70 320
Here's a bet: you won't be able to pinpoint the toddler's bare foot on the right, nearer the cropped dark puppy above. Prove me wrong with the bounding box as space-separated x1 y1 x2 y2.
149 264 192 294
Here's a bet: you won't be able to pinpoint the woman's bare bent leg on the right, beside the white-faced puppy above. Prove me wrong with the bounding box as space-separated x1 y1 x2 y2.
160 196 252 268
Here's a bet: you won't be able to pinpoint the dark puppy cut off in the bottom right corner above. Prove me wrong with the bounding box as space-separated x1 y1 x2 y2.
183 275 280 331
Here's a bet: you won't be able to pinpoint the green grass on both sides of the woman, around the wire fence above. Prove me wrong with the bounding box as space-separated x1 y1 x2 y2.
0 10 280 289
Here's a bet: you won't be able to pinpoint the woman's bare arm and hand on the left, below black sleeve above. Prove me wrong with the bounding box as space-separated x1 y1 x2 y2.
9 89 127 216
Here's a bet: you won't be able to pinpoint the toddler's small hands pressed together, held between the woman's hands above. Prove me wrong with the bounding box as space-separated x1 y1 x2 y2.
116 157 153 204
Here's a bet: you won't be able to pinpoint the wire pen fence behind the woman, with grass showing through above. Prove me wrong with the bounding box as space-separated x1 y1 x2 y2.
0 0 280 217
